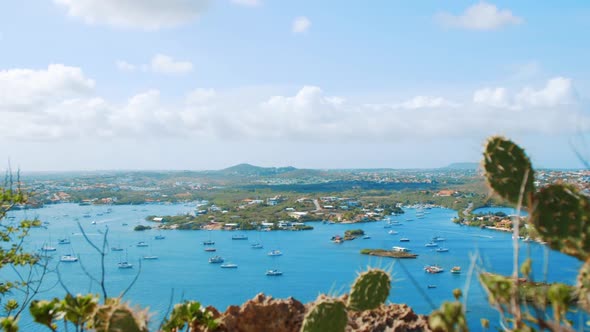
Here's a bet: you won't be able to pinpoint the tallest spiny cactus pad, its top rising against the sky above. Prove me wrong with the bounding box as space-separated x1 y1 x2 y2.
483 136 535 205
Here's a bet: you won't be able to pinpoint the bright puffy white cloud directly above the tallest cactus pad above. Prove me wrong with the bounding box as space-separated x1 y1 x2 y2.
473 77 577 110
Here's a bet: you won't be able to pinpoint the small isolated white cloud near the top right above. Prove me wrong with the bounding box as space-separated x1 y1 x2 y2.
436 1 524 30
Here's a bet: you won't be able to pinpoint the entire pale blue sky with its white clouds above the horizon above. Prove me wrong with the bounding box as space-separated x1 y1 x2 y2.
0 0 590 171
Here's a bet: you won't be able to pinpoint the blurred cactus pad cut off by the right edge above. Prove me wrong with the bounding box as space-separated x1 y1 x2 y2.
530 184 590 261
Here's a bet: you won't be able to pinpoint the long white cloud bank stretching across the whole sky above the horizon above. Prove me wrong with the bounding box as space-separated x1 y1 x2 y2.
0 65 590 142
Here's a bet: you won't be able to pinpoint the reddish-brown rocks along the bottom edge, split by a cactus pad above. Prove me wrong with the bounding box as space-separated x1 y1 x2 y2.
213 293 430 332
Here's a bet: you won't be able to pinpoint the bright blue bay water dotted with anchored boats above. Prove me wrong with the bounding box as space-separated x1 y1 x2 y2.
6 204 580 331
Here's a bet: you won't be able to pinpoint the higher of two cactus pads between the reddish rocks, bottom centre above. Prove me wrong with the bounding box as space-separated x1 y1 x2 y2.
348 269 391 311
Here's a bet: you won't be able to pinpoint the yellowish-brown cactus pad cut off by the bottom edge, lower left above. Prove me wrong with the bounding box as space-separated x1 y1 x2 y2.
93 302 148 332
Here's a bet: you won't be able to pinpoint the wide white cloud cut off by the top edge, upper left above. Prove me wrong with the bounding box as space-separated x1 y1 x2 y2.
54 0 210 30
